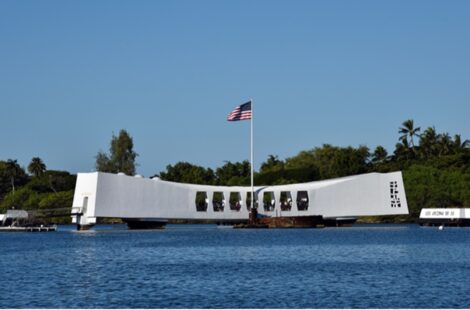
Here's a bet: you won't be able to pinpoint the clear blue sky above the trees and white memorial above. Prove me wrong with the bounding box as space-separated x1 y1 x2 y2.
0 0 470 176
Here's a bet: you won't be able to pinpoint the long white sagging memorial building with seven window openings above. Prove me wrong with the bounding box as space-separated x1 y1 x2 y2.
73 172 408 224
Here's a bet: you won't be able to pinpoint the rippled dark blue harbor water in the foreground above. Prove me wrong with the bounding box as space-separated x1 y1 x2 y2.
0 225 470 308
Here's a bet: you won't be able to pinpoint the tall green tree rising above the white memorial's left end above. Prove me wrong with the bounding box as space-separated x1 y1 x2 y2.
96 129 138 175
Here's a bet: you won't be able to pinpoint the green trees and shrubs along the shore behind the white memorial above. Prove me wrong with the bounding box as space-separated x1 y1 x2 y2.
0 119 470 224
